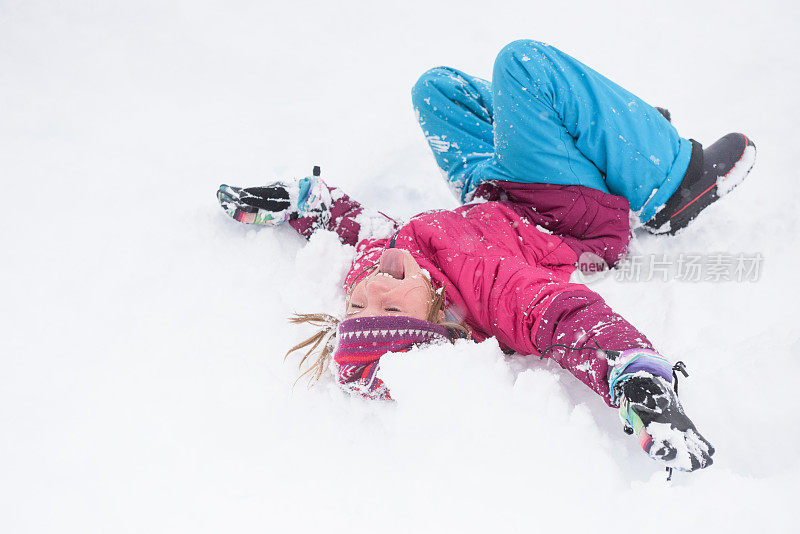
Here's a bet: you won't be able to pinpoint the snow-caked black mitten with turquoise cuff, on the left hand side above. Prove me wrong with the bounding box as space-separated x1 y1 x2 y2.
217 176 331 226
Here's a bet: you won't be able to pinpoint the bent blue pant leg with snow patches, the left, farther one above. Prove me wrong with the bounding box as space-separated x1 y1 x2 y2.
411 67 509 202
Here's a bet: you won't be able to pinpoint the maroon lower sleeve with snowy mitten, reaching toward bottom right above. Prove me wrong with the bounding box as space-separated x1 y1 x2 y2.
535 289 714 471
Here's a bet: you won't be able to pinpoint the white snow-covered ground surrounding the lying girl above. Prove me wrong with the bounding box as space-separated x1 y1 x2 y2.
0 0 800 534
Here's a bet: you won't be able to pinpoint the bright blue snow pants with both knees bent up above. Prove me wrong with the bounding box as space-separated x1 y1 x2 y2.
412 40 692 222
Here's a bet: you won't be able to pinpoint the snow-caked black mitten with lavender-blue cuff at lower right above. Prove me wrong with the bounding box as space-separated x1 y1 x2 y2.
609 349 714 471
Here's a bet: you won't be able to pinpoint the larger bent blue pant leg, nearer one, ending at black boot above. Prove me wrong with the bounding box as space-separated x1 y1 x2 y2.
492 40 691 222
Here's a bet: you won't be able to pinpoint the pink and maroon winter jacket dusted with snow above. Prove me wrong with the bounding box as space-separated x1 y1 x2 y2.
291 182 651 404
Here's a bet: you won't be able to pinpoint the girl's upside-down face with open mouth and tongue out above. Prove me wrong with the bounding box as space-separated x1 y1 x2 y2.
347 248 432 320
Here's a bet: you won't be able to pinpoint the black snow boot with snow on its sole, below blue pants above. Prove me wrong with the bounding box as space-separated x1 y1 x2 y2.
645 133 756 235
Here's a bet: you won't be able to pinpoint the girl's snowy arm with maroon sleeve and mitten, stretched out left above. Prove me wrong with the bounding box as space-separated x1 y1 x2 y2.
217 167 397 246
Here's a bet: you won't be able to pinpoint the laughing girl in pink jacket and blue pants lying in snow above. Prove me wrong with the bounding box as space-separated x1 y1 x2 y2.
217 41 755 471
